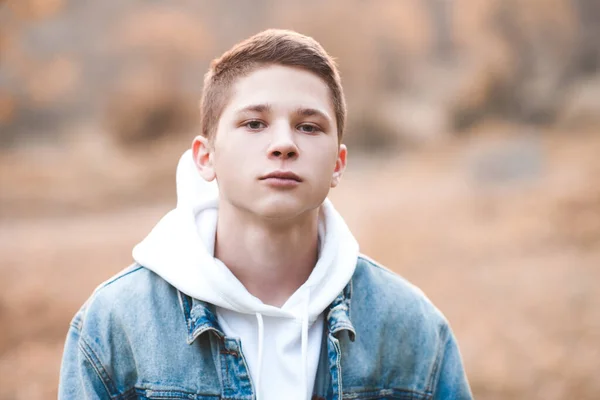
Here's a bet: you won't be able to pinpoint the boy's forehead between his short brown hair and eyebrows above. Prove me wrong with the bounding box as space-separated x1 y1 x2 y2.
223 65 335 116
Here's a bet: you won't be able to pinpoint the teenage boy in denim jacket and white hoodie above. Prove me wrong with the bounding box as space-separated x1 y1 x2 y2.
59 30 471 399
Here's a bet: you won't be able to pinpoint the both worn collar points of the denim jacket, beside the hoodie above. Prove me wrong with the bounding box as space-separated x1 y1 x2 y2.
178 280 356 344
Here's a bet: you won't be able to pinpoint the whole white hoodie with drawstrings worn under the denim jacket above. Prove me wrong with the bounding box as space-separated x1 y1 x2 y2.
133 150 358 400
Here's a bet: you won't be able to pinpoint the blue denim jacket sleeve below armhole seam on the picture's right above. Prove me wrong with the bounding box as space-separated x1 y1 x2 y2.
433 327 473 400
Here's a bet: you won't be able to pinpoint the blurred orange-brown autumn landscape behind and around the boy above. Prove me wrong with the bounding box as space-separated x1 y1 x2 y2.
0 0 600 400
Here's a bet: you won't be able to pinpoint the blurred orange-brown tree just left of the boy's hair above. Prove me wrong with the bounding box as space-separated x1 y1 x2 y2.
105 5 213 146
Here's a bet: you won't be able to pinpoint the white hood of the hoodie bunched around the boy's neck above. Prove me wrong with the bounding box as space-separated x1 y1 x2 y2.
133 150 359 320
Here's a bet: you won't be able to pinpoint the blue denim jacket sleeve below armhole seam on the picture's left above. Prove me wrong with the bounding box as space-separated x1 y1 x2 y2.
58 317 111 400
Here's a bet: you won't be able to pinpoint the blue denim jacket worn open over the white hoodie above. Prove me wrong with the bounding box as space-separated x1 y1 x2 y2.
59 256 472 400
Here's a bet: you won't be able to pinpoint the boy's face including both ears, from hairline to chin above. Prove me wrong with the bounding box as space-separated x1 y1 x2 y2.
193 65 347 219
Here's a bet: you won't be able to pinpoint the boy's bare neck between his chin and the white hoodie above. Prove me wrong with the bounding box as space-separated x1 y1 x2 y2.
215 202 319 307
